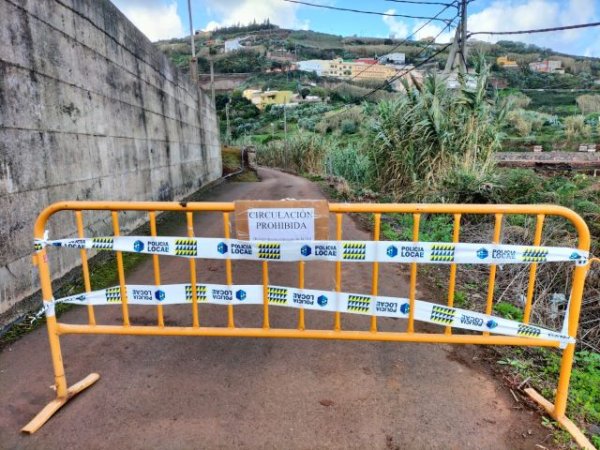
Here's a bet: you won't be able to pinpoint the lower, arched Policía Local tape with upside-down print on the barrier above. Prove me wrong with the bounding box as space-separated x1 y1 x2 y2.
52 284 575 346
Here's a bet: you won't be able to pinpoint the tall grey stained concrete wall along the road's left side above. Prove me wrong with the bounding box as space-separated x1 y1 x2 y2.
0 0 221 323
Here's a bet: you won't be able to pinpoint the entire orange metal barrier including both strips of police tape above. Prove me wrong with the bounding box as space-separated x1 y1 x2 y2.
23 202 593 448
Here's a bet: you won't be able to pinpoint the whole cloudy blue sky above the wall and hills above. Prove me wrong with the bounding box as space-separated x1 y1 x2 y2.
113 0 600 57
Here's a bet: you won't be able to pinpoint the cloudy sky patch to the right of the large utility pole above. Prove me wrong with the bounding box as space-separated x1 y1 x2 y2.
468 0 600 55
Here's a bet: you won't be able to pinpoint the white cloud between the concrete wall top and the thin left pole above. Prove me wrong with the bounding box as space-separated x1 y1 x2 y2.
114 0 187 41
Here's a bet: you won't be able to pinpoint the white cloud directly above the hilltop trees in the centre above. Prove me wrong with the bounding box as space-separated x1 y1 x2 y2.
206 0 310 30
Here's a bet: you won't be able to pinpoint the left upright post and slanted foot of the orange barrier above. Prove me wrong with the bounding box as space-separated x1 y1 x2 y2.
21 250 100 434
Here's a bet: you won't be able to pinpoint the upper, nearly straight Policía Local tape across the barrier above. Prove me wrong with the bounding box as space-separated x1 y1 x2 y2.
34 236 588 265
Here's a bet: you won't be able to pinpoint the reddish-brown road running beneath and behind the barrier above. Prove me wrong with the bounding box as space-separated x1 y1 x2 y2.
0 169 549 450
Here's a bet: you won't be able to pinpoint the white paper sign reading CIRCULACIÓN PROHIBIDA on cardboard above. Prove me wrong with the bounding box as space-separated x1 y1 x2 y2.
248 208 315 241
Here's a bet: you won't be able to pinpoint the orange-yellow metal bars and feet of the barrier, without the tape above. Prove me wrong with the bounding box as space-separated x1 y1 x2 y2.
22 202 593 448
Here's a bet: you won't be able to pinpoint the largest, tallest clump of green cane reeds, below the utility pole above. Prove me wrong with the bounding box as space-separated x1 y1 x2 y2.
365 57 505 200
